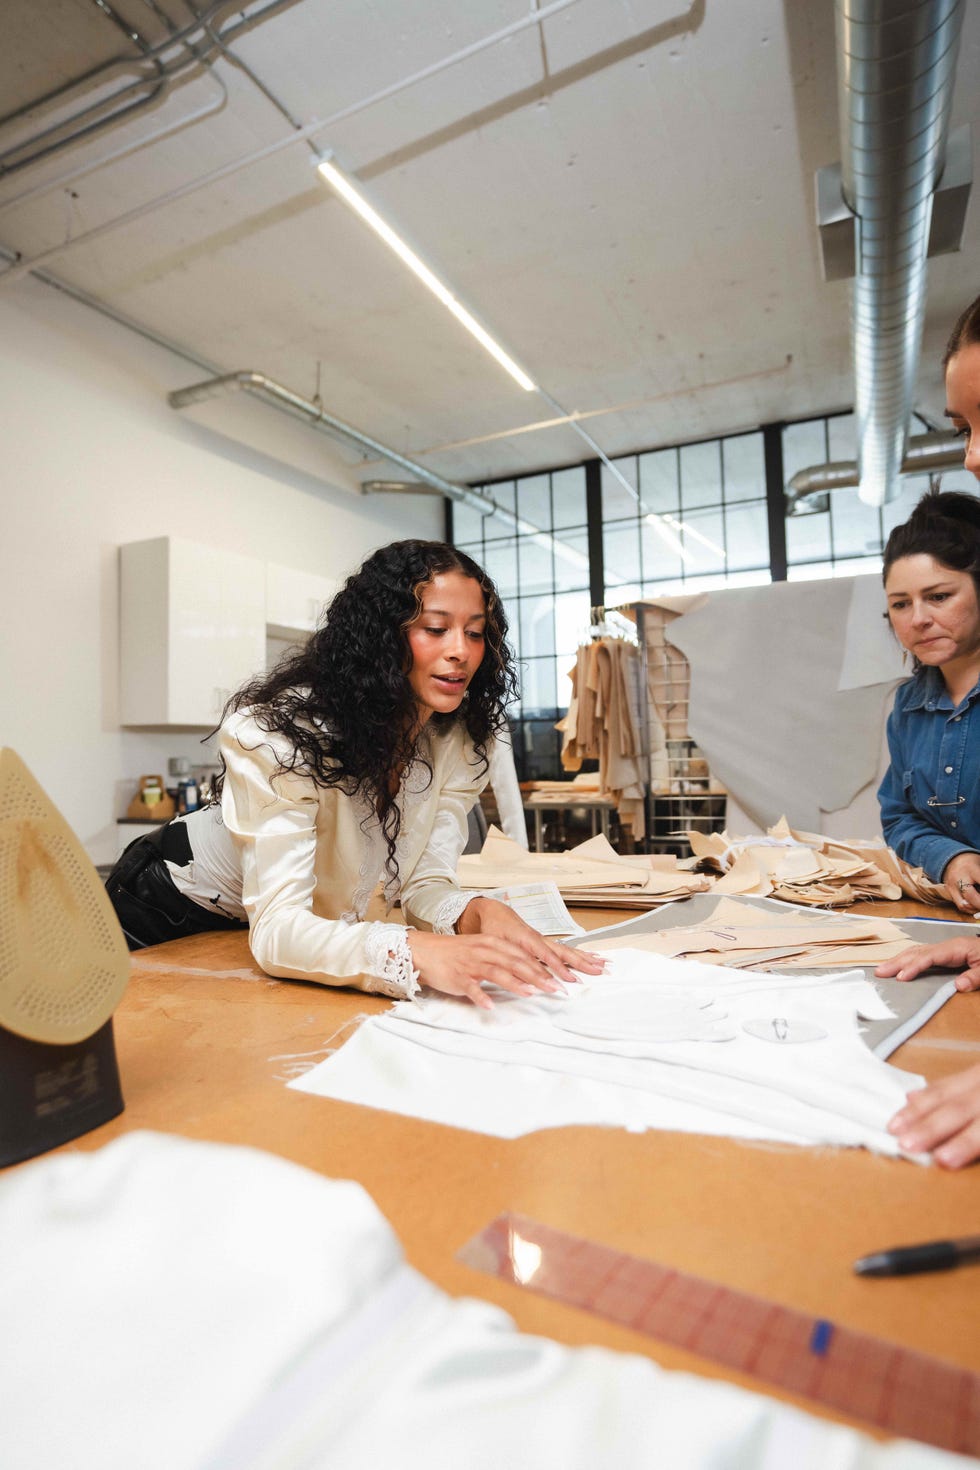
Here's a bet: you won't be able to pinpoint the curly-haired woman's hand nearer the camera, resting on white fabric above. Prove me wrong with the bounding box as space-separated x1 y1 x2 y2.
407 929 564 1010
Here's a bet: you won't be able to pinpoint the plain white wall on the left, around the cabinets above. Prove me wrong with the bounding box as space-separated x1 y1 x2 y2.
0 279 444 861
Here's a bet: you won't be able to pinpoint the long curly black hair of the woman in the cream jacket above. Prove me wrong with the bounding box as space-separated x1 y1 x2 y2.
213 541 517 876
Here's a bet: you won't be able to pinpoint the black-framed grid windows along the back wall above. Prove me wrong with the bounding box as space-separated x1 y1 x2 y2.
447 412 977 781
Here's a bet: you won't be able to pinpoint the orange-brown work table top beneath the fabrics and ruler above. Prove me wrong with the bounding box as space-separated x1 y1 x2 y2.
69 904 980 1440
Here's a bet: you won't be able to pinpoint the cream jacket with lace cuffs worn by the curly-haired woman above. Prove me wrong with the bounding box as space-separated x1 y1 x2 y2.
167 710 486 998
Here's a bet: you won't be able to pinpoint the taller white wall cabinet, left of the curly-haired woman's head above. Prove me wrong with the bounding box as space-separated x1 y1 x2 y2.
120 537 266 729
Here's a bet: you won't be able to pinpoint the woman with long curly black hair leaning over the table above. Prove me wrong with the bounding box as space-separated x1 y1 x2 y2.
106 541 601 1007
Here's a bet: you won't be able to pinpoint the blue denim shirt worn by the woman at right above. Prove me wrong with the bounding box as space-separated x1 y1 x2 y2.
879 667 980 883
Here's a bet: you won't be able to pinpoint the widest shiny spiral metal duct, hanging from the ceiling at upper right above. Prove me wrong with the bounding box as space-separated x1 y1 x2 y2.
835 0 964 506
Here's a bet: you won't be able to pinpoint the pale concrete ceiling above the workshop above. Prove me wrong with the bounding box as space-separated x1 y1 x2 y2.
0 0 980 493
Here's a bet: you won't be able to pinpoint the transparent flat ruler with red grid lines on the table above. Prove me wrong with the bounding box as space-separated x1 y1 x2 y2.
460 1214 980 1455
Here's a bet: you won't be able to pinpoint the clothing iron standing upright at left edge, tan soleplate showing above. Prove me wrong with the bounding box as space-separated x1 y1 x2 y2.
0 747 129 1167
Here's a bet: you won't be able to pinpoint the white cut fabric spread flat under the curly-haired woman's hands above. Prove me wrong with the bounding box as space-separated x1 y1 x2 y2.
289 950 923 1154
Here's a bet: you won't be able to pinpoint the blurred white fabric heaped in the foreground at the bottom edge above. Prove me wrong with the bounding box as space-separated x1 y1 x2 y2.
0 1133 973 1470
